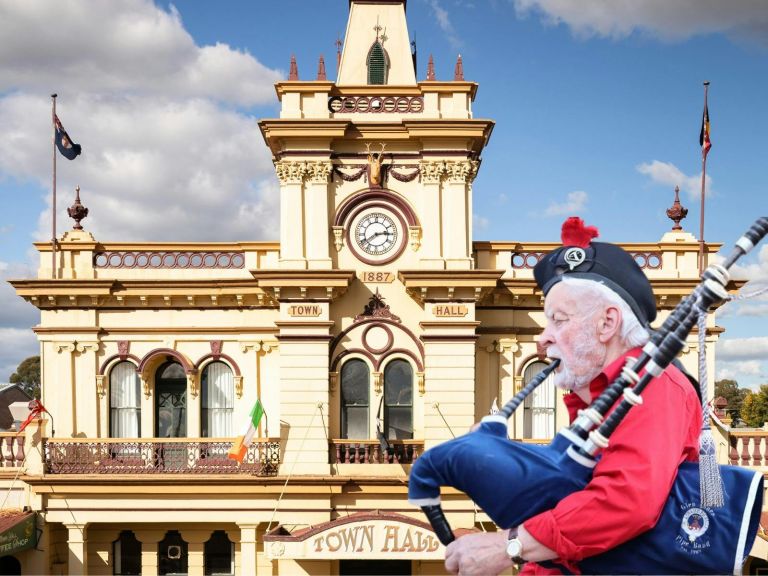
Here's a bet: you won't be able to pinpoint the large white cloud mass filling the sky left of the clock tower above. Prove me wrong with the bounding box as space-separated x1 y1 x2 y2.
0 0 281 241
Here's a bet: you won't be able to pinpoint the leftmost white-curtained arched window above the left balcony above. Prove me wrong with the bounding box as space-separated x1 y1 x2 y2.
109 362 141 438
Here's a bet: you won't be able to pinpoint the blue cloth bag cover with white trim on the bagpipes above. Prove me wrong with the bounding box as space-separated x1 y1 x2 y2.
408 421 763 574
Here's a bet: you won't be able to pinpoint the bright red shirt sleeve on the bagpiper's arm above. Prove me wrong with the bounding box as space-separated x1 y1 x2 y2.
524 367 701 565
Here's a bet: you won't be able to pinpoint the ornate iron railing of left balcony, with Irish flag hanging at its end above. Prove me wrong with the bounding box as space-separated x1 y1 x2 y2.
45 438 280 476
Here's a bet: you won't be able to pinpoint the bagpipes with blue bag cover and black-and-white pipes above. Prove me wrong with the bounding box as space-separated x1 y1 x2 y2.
408 217 768 574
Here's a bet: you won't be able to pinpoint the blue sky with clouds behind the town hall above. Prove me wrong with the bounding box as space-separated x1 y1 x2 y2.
0 0 768 388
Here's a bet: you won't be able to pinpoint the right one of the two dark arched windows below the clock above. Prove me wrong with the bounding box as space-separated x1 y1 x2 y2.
384 360 413 440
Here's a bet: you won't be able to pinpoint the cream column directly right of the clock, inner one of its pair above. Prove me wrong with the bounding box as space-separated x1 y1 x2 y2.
419 160 445 270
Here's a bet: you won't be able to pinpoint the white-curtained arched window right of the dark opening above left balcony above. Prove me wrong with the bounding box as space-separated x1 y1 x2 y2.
200 362 235 438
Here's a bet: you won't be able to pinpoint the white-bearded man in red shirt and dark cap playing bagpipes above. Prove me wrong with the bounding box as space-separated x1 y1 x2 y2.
445 218 701 575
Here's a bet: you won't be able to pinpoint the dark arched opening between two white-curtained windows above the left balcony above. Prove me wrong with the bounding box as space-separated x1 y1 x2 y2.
155 361 187 438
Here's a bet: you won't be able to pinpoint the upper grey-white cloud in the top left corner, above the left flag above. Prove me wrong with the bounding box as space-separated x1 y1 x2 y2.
0 0 282 105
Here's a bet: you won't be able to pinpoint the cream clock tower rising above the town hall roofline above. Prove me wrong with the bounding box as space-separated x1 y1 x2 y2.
260 0 493 270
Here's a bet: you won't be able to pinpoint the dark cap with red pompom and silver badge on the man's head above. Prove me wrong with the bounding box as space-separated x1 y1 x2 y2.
533 216 656 327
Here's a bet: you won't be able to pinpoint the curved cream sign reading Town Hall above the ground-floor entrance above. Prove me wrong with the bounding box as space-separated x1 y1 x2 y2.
265 514 445 560
